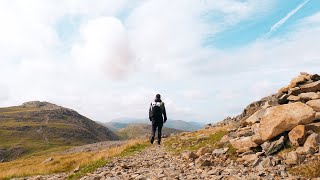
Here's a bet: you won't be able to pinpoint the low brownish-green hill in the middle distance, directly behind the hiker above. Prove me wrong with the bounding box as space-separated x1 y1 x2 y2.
116 124 183 139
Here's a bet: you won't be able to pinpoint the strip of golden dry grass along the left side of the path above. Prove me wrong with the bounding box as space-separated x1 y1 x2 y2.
0 140 148 179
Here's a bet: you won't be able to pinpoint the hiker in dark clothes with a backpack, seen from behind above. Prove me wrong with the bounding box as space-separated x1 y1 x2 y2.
149 94 167 145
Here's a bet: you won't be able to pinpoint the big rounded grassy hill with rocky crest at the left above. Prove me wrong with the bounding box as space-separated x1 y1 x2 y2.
0 101 118 162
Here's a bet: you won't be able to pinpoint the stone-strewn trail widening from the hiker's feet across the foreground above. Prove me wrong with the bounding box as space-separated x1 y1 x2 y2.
81 145 298 180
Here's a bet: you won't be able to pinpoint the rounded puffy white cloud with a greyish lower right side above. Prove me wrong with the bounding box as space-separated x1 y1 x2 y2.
71 17 134 79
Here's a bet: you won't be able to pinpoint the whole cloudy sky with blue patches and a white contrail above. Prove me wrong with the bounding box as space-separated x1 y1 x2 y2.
0 0 320 123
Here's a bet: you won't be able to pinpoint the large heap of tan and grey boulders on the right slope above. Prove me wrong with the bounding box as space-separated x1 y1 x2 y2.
205 73 320 179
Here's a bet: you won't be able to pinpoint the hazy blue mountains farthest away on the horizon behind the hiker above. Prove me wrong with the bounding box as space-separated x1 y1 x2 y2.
103 118 205 131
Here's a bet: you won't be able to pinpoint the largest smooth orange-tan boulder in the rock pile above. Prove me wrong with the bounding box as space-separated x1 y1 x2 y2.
258 102 315 141
